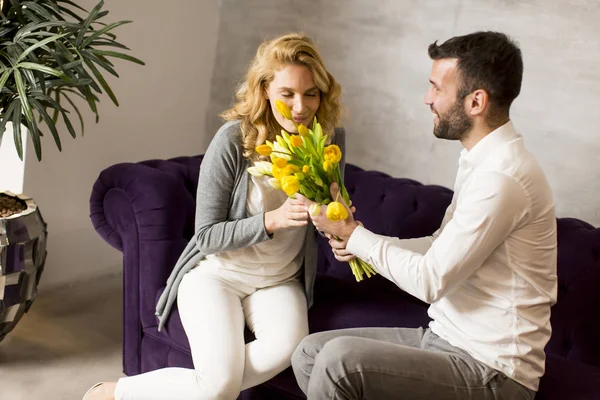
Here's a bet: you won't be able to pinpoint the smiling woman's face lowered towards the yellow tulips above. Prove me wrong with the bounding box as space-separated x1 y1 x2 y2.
267 64 321 133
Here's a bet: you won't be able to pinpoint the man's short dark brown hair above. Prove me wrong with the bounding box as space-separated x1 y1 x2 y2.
429 32 523 120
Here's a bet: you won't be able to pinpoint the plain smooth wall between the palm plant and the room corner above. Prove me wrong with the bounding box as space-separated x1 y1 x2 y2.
24 0 219 288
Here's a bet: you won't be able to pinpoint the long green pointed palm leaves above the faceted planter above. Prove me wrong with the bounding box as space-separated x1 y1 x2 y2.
0 0 145 160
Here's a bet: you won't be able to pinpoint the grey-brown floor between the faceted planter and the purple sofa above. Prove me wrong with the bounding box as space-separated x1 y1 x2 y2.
0 275 123 400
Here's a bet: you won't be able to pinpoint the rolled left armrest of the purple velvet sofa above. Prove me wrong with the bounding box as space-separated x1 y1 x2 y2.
90 157 201 344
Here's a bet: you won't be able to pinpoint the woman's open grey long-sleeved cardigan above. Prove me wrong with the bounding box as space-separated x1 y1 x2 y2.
156 121 346 331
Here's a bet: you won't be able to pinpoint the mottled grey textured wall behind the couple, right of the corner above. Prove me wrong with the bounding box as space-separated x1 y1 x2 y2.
203 0 600 226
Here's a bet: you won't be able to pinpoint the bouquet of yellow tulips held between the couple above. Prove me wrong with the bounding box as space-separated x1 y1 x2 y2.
248 100 376 282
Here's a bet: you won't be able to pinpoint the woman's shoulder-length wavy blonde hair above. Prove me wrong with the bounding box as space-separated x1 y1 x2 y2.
220 33 342 159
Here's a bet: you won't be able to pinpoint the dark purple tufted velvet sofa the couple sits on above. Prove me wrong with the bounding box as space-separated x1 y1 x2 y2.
90 156 600 400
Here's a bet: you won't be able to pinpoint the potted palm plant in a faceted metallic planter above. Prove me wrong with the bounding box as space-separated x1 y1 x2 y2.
0 0 144 341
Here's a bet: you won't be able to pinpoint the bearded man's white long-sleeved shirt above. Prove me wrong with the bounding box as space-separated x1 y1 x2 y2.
347 121 557 390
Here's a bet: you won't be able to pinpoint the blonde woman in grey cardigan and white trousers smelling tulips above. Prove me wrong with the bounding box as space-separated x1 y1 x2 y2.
84 34 345 400
